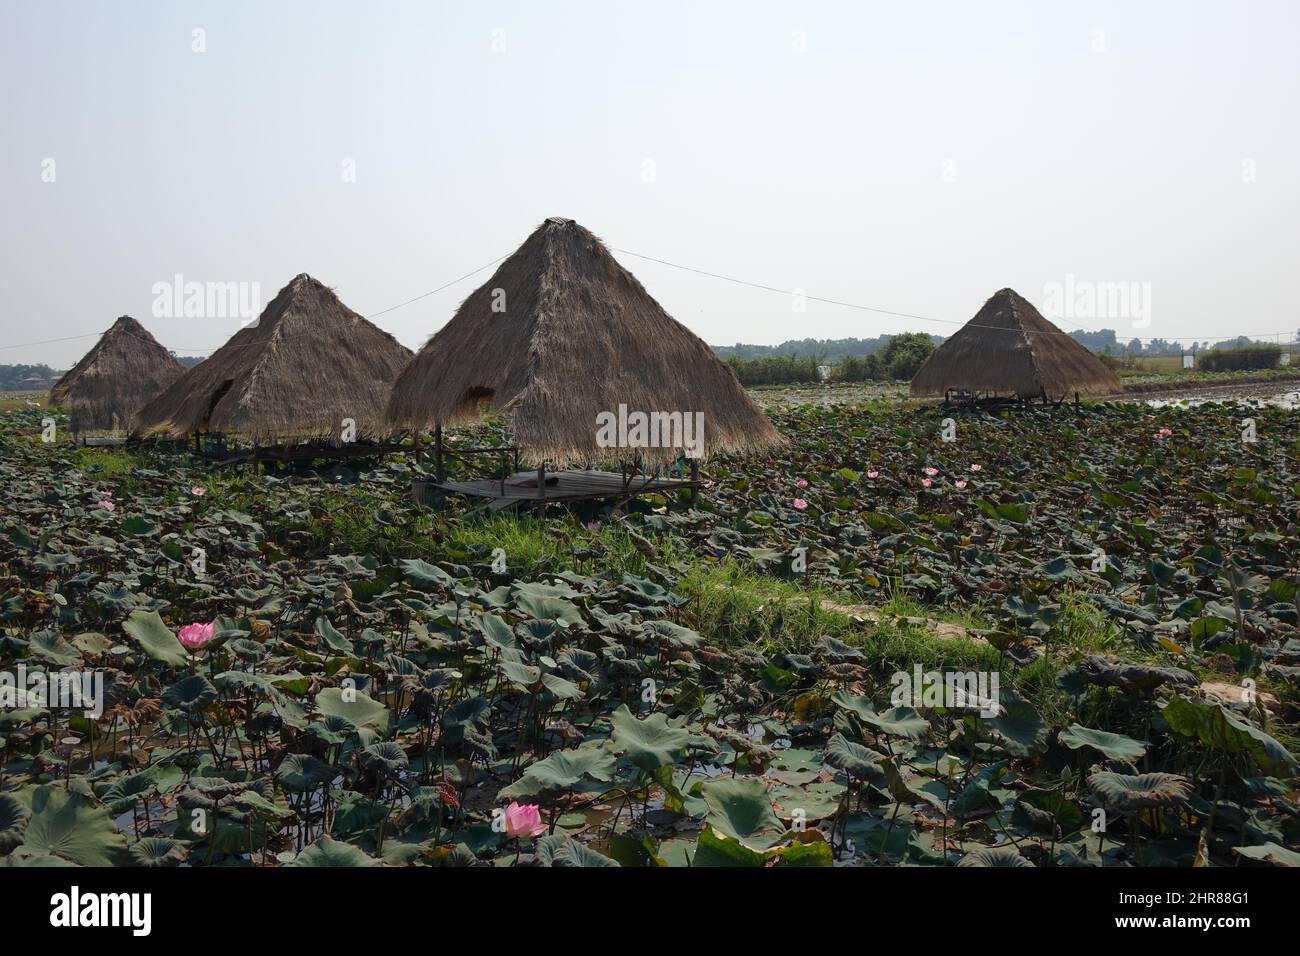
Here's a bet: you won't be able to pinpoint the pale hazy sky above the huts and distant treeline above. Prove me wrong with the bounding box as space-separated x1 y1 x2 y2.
0 0 1300 367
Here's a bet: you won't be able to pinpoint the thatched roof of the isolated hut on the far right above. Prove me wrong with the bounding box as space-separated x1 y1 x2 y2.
911 289 1123 398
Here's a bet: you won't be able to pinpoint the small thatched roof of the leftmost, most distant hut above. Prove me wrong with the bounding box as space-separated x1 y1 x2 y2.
49 315 185 432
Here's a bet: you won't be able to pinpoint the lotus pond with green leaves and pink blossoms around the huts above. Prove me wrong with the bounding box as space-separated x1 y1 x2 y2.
0 393 1300 866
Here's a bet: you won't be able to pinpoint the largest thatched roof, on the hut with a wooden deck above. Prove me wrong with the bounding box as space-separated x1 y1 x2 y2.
387 219 781 464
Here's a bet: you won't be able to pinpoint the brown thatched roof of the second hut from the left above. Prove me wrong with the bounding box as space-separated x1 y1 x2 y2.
135 273 411 444
